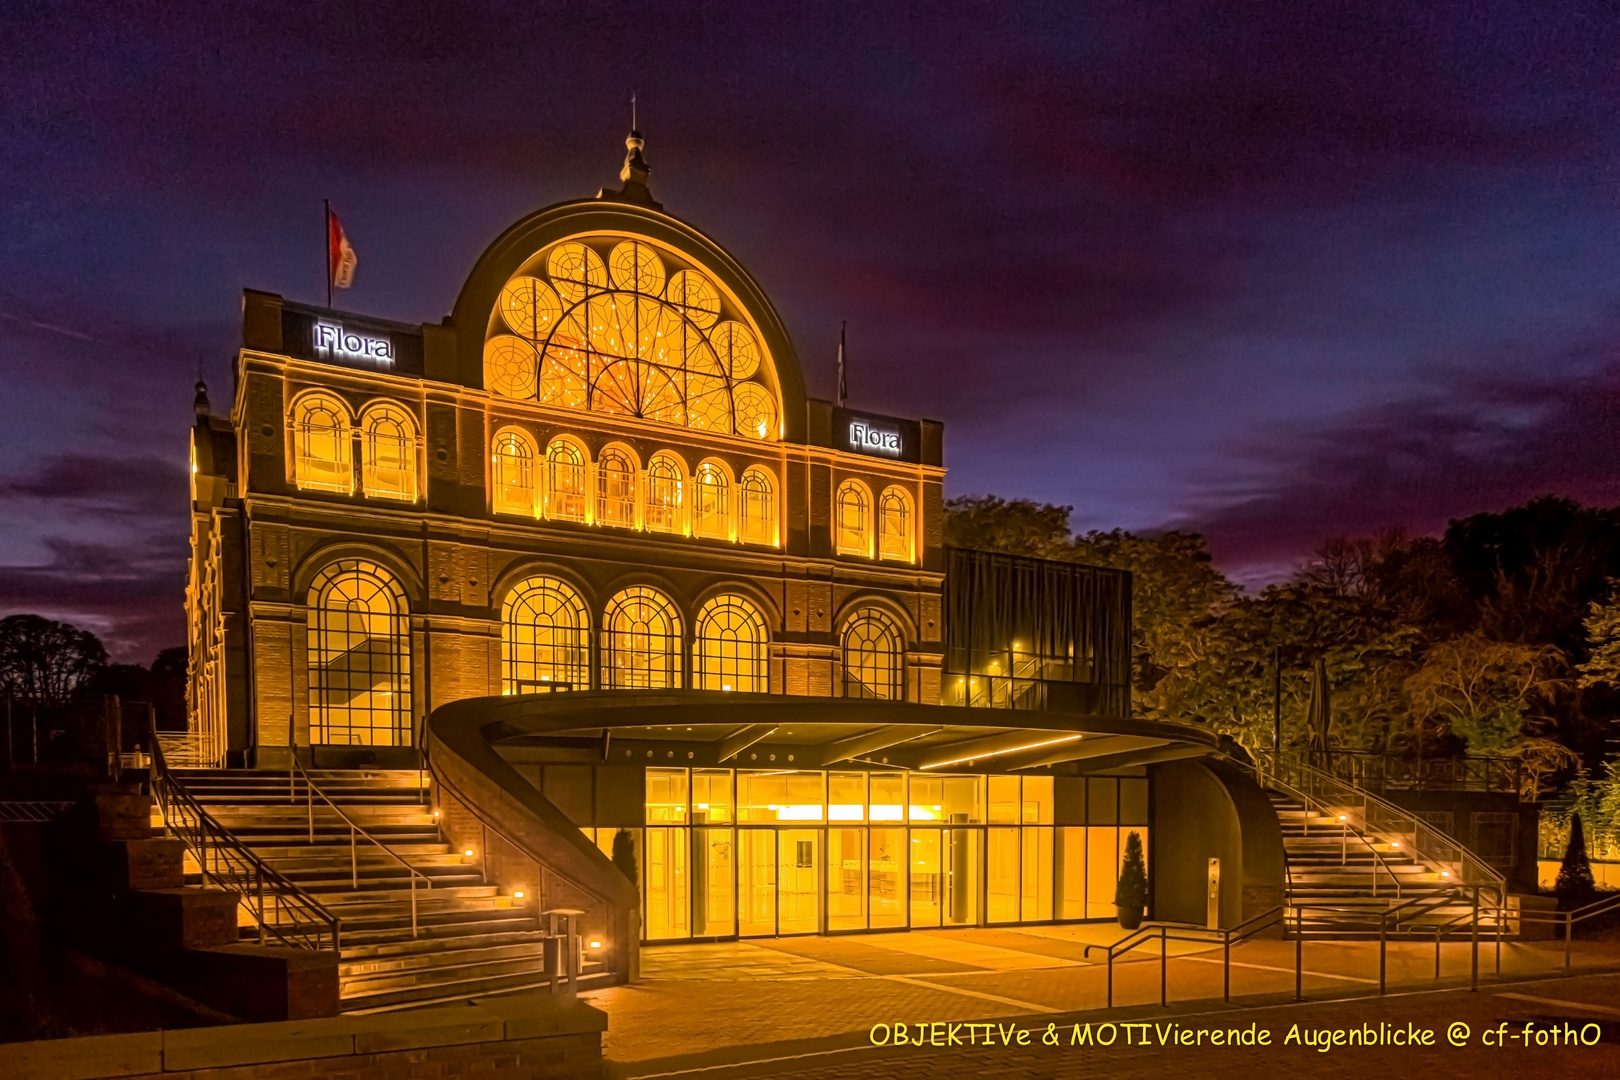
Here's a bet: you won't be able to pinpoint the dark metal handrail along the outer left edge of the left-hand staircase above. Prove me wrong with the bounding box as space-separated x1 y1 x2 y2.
149 721 342 952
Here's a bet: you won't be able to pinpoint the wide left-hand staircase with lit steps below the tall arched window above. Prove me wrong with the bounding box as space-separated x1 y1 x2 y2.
162 769 608 1012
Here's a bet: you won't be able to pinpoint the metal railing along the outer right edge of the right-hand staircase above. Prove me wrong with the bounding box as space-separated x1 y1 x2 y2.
1252 753 1507 905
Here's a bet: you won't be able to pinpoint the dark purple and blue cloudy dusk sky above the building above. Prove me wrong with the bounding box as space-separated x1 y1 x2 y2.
0 0 1620 662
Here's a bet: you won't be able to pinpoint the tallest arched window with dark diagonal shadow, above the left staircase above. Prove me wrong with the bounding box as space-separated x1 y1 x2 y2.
309 559 413 746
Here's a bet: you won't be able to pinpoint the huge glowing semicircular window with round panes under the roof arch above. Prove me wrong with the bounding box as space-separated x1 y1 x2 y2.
484 235 781 439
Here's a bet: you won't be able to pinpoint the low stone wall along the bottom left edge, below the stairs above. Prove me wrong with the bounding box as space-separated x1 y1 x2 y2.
11 993 608 1080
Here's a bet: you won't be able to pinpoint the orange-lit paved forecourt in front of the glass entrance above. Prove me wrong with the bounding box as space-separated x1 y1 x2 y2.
590 925 1620 1080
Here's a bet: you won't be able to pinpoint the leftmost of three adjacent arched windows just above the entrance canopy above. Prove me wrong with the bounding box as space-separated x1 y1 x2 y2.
501 578 591 693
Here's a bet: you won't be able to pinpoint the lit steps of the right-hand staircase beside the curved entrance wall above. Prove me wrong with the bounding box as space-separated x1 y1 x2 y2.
1267 792 1494 941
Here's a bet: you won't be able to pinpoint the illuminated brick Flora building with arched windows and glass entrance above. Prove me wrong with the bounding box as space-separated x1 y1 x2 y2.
188 134 1276 939
